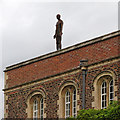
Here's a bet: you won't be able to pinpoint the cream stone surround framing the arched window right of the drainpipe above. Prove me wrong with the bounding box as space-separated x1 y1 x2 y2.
92 70 117 109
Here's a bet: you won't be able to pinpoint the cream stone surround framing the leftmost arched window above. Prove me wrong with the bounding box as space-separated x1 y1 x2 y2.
26 89 46 118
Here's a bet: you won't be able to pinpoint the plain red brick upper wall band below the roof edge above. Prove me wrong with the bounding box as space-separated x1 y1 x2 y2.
6 36 120 88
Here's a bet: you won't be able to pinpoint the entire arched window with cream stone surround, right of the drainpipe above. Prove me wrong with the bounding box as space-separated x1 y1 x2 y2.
92 71 117 109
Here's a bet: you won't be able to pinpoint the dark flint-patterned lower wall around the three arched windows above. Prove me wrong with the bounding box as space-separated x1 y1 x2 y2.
6 58 120 118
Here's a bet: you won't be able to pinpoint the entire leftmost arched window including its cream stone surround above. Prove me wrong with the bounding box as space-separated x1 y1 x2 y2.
26 92 46 117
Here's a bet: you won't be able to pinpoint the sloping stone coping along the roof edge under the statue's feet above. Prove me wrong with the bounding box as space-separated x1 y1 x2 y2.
4 30 120 72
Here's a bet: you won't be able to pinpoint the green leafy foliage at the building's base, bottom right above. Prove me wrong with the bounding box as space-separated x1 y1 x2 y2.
68 101 120 120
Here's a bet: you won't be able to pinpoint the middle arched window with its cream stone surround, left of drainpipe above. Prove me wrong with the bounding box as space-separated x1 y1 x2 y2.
57 83 79 118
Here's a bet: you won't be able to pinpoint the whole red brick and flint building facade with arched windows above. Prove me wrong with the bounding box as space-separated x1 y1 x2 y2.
4 31 120 118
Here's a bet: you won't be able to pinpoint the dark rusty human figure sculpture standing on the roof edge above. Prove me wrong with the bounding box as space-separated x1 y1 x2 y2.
54 14 63 50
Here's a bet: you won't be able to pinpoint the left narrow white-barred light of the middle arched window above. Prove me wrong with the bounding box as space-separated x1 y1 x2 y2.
65 90 70 118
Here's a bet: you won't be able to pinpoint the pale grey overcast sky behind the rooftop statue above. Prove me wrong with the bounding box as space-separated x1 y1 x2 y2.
0 0 119 119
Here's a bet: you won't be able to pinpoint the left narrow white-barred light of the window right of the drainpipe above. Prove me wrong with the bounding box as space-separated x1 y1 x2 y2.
101 81 107 109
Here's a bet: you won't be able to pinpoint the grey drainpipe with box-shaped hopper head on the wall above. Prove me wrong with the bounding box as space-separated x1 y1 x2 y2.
80 60 88 109
